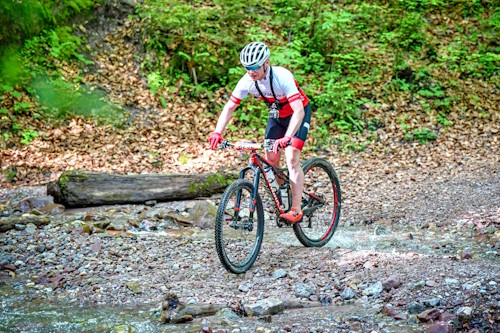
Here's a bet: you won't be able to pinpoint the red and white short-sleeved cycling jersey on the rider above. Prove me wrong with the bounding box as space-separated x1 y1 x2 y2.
231 66 309 118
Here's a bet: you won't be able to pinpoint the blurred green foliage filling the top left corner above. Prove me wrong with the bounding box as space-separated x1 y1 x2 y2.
0 0 101 144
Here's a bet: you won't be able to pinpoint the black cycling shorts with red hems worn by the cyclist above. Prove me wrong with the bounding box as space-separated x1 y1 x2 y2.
265 103 311 150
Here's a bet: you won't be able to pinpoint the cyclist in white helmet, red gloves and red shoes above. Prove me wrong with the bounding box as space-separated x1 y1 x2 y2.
208 42 311 223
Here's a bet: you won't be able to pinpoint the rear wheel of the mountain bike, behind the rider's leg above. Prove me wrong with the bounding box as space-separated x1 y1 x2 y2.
293 158 341 247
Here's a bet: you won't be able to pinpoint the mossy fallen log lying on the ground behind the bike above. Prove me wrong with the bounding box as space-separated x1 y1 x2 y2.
47 170 236 207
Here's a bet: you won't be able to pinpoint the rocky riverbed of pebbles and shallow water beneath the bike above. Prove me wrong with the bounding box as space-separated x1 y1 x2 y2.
0 158 500 332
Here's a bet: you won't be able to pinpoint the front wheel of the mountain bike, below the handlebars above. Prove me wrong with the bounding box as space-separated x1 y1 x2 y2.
215 179 264 274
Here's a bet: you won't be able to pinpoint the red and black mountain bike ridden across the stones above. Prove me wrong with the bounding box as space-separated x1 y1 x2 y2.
215 140 341 274
